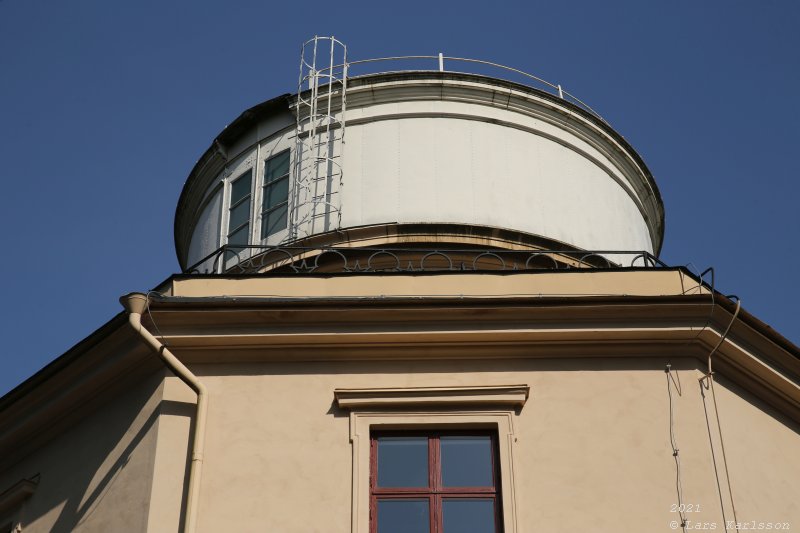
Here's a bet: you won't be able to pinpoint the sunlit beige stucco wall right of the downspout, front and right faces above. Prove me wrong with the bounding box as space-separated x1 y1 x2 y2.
151 354 800 533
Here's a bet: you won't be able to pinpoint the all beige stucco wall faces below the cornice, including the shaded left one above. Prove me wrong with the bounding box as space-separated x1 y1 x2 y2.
0 342 800 533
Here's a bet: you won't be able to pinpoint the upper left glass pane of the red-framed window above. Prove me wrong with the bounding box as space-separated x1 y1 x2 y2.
378 437 428 487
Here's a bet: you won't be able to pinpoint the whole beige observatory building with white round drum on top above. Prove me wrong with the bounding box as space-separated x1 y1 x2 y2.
0 38 800 533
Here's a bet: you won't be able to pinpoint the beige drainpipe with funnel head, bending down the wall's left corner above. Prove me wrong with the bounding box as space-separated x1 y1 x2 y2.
119 292 208 533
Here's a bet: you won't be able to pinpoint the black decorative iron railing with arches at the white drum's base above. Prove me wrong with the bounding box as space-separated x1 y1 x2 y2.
184 245 668 274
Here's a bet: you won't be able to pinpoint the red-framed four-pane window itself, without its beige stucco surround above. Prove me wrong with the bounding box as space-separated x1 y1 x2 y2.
370 431 501 533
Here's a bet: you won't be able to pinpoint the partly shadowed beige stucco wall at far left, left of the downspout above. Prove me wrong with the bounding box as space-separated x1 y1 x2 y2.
0 374 162 533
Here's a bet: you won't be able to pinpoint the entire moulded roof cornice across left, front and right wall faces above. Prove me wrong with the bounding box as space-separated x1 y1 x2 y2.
0 288 800 468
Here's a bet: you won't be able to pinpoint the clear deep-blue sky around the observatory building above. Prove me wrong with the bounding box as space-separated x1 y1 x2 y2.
0 0 800 394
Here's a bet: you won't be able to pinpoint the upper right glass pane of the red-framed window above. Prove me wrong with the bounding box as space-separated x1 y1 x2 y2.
440 435 494 487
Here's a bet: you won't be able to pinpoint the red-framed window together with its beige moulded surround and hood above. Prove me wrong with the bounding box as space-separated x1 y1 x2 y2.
334 385 530 533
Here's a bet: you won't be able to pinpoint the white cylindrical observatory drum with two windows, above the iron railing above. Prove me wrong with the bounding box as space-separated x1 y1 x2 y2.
175 72 664 268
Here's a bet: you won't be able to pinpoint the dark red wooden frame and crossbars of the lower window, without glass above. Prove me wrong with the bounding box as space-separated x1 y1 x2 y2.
369 430 503 533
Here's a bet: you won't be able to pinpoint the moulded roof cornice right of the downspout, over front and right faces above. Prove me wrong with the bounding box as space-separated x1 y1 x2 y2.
141 294 800 420
